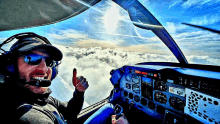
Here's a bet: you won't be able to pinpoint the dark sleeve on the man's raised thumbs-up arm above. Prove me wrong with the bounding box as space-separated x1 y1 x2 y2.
50 89 84 123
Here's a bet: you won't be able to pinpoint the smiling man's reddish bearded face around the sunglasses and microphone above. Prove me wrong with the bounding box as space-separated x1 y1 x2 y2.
18 50 52 94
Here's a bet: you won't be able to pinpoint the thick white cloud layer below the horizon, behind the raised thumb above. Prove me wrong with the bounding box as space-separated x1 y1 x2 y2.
52 45 220 104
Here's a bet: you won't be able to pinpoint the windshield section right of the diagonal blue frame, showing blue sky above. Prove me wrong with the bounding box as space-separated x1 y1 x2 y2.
139 0 220 65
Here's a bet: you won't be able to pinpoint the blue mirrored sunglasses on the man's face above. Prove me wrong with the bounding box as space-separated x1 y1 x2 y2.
24 54 55 67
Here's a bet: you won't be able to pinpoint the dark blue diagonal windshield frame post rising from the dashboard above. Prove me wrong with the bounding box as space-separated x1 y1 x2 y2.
113 0 188 64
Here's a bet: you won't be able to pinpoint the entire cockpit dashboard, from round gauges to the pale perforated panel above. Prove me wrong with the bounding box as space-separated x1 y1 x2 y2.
111 65 220 124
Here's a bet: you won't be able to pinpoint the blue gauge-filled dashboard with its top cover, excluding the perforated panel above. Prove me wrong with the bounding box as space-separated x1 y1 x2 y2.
114 65 220 122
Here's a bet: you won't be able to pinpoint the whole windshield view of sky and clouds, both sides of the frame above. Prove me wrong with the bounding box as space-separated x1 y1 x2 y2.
0 0 220 105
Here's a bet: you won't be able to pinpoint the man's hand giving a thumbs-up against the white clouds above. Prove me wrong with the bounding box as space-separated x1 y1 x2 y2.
73 68 89 92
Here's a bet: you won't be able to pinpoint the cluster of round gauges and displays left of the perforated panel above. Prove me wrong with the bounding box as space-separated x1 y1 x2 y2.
120 70 185 114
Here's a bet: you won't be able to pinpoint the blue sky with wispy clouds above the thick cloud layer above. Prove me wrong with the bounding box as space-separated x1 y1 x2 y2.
0 0 220 60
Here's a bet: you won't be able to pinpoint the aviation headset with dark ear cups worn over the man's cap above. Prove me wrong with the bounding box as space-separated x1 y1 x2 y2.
0 32 60 84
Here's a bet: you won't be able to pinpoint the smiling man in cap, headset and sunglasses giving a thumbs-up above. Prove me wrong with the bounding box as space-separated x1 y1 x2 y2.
0 33 129 124
